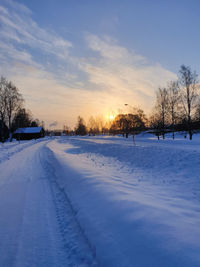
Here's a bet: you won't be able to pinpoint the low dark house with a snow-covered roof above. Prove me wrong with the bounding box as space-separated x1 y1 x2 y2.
13 127 44 140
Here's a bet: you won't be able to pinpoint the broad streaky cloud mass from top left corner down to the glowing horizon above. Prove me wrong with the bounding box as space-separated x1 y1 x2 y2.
0 0 176 127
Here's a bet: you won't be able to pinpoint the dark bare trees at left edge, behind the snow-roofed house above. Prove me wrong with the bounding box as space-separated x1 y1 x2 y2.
0 76 41 142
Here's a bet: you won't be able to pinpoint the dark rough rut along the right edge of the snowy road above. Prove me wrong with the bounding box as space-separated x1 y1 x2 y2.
40 147 98 267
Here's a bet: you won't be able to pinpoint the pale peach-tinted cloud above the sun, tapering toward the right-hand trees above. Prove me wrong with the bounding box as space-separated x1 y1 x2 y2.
81 34 176 101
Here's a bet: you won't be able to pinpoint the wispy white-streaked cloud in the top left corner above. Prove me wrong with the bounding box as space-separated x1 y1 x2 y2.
0 0 72 65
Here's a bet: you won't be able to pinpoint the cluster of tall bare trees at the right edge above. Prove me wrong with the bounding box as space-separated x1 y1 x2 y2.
149 65 200 140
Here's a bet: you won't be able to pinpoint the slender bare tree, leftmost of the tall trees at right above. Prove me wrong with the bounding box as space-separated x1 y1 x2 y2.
155 88 168 139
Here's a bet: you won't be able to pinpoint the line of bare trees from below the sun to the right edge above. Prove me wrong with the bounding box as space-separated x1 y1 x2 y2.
72 65 200 140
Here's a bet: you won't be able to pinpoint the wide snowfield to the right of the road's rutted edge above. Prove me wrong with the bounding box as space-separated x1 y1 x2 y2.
48 137 200 267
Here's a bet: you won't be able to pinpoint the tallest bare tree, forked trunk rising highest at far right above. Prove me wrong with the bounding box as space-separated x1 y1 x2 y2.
179 65 198 140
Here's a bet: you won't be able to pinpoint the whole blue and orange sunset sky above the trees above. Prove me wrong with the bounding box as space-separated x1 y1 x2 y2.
0 0 200 128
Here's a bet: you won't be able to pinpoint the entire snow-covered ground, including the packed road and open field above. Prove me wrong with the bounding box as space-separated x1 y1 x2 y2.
0 134 200 267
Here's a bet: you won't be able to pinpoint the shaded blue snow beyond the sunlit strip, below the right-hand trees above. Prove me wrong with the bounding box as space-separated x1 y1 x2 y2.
65 135 200 200
